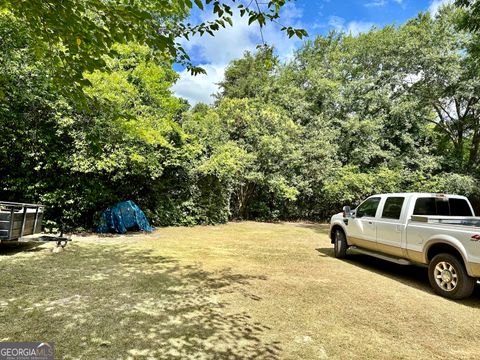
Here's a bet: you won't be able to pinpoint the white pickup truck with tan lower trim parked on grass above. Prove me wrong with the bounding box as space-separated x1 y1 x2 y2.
330 193 480 299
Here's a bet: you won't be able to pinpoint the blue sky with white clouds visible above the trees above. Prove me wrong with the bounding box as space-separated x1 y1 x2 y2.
173 0 451 105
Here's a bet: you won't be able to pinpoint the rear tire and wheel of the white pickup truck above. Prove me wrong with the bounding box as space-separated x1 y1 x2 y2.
428 253 477 300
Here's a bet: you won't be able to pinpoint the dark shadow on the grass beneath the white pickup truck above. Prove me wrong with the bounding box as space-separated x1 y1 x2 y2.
315 245 480 308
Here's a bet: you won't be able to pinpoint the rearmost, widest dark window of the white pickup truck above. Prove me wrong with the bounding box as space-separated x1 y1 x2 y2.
413 197 473 216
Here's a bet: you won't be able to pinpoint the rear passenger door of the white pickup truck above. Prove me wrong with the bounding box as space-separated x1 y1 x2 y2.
377 196 405 257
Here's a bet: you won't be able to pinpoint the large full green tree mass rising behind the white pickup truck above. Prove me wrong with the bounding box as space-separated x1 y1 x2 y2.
270 8 478 216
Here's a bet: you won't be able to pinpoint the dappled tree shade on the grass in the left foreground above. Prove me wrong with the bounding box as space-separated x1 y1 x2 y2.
0 244 281 359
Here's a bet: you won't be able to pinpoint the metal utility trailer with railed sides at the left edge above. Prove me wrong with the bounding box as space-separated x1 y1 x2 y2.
0 201 70 247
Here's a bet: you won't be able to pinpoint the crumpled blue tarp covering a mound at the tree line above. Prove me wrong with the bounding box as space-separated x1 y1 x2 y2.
97 200 154 234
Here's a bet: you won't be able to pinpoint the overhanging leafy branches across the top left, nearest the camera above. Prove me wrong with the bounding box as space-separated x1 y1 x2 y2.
0 0 307 85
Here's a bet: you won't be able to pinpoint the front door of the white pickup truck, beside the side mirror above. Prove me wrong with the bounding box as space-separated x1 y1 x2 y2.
347 197 381 250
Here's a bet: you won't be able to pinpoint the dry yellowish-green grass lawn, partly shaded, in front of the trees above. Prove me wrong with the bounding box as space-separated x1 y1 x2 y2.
0 222 480 360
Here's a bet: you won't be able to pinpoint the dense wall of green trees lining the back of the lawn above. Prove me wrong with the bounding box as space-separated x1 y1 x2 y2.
0 0 480 229
